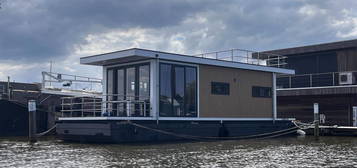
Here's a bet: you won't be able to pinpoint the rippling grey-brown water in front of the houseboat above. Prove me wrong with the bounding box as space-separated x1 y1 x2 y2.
0 137 357 168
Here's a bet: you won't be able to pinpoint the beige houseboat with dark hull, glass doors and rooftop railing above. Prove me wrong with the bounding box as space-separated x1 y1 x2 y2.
56 48 297 143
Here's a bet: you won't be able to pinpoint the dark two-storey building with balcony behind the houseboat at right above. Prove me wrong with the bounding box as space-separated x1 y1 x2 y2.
265 40 357 126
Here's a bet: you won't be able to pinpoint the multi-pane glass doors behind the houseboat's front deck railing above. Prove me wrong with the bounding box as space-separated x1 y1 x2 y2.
107 64 150 117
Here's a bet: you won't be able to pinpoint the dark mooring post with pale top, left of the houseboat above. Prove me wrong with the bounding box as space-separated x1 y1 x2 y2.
28 100 37 143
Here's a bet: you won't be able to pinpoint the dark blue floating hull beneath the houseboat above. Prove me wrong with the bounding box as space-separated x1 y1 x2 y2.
56 120 297 143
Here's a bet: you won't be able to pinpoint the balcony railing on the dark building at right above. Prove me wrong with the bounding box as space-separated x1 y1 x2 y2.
277 71 357 89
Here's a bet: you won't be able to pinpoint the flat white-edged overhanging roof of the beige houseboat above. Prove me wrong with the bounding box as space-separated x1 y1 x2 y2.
80 48 295 74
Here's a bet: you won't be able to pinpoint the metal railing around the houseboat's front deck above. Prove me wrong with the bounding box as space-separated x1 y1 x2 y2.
61 94 151 117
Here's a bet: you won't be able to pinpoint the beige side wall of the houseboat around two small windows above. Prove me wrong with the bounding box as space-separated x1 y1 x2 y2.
199 65 273 118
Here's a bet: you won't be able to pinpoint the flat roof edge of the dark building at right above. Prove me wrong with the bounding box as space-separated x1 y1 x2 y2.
263 39 357 56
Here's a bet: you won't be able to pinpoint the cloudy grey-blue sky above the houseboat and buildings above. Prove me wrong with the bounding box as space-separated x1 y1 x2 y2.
0 0 357 82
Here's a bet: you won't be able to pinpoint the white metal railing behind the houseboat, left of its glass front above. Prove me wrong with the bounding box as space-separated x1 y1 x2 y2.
42 72 102 94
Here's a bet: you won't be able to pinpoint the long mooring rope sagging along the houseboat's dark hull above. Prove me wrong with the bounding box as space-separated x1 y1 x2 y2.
126 121 299 140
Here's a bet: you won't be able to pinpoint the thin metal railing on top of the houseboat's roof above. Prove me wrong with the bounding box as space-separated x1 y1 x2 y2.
194 49 287 68
